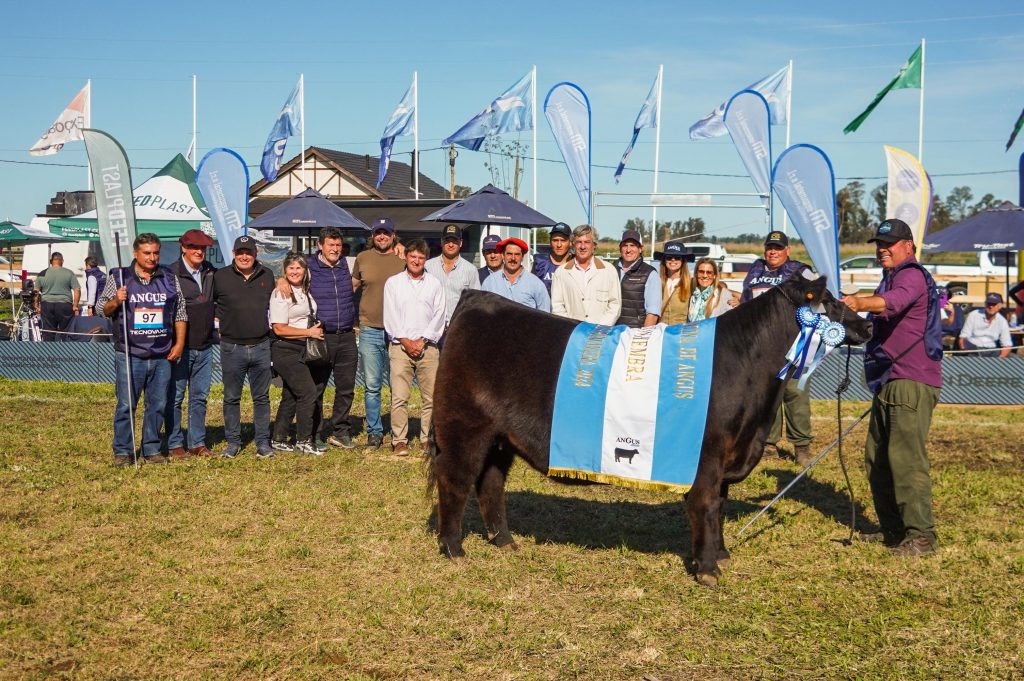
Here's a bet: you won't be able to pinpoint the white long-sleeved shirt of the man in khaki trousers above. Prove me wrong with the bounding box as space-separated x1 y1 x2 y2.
384 270 446 343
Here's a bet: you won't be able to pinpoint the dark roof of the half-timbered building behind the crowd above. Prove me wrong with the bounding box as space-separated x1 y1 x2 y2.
249 146 449 200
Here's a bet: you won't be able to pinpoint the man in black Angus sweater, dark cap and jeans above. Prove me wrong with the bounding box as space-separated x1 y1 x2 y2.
213 236 274 459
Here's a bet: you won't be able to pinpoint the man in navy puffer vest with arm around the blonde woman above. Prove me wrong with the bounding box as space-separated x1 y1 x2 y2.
278 227 358 450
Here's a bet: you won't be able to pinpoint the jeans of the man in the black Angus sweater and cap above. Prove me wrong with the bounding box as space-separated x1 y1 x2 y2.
220 339 270 452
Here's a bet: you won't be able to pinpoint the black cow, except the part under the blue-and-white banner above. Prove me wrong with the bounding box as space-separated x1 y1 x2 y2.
428 278 870 585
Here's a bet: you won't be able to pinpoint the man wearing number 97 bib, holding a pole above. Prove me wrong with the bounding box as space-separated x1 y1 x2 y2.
96 232 188 467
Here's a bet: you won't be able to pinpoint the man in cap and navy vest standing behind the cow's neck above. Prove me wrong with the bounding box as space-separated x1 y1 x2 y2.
739 231 813 466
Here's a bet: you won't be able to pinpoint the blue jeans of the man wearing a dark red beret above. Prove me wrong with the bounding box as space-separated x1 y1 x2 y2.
166 347 213 450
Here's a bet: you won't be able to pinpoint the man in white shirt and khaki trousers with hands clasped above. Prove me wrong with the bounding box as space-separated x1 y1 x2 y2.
384 239 445 457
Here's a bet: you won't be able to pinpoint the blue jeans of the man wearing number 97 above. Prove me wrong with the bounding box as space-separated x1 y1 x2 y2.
113 352 171 457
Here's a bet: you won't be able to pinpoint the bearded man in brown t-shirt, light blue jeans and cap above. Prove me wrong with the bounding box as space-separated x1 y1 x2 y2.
352 217 406 449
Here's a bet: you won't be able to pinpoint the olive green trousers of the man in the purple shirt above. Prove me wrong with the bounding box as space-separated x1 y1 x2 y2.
864 380 939 543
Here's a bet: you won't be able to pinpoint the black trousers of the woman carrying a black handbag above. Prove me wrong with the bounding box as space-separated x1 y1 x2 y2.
270 340 331 442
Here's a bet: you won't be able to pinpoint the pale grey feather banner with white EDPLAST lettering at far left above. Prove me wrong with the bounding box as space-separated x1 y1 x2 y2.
83 128 135 267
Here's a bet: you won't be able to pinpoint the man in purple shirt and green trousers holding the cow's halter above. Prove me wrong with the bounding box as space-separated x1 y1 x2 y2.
843 219 942 556
